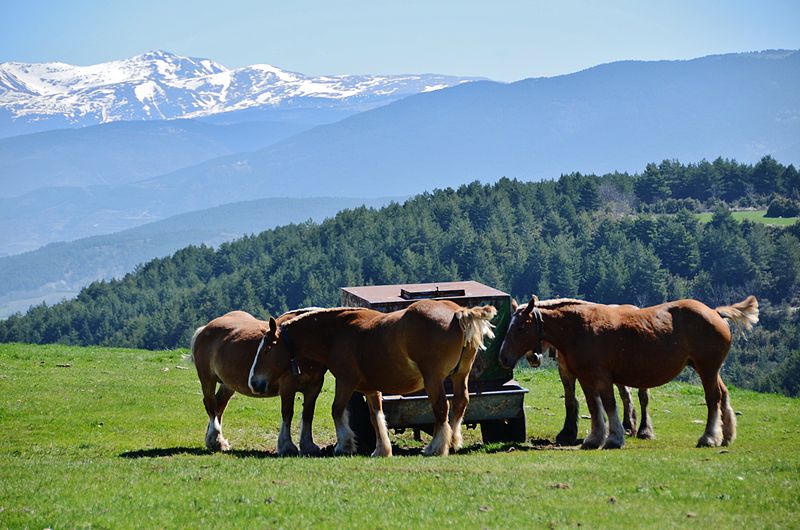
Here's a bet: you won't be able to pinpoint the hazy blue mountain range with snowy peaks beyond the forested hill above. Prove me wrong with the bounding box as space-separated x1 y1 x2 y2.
0 50 800 314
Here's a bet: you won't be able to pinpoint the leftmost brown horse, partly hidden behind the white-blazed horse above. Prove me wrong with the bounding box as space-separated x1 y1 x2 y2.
191 309 325 456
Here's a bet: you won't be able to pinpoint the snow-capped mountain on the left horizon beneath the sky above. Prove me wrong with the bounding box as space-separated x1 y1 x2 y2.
0 51 482 134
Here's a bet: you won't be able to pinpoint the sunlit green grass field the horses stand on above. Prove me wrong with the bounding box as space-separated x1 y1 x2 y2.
0 344 800 528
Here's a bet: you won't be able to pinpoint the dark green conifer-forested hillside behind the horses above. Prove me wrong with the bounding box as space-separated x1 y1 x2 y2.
0 157 800 395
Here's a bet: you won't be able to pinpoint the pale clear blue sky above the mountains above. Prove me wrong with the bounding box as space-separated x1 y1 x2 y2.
0 0 800 81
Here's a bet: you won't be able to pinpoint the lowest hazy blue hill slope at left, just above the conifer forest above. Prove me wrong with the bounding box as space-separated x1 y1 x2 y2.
0 198 389 318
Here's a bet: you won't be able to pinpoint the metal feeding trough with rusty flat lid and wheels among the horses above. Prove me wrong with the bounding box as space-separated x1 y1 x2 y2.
342 281 528 453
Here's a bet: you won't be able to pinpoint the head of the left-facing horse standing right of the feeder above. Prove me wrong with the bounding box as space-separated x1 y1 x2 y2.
499 295 543 368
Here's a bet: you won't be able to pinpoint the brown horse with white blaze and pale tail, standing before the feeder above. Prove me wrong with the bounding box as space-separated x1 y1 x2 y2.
250 300 497 456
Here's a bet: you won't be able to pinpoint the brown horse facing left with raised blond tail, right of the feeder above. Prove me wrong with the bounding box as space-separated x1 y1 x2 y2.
500 296 758 449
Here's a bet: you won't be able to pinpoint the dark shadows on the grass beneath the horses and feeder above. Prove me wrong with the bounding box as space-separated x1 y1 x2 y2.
119 438 580 459
